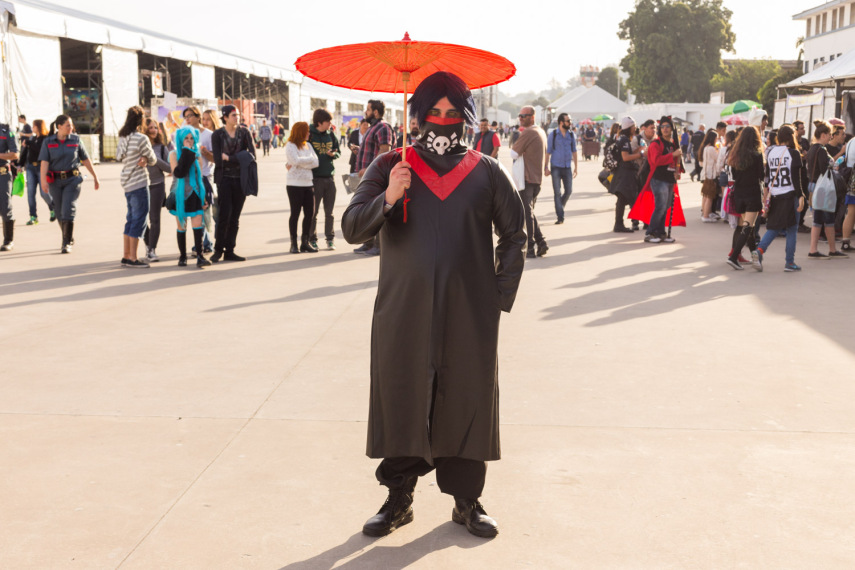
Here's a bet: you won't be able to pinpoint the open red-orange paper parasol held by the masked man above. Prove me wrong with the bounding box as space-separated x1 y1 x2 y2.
294 34 516 158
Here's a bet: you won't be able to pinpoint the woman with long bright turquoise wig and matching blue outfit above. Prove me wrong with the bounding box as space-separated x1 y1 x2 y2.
168 127 211 268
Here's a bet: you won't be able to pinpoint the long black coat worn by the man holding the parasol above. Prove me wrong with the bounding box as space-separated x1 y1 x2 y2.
342 147 526 463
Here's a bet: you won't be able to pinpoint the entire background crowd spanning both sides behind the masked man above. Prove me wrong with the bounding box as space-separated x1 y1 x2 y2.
0 100 855 271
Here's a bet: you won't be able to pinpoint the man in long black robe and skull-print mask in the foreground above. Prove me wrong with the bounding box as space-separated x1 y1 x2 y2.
342 72 526 538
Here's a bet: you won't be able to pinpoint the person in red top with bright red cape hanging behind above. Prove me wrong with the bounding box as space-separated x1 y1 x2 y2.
629 117 686 243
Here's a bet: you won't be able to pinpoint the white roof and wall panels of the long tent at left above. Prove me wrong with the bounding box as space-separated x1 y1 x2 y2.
0 0 303 126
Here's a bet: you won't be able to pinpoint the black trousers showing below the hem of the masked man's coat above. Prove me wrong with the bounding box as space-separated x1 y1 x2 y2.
375 457 487 499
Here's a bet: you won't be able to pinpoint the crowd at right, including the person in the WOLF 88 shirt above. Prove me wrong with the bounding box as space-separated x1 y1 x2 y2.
601 111 855 272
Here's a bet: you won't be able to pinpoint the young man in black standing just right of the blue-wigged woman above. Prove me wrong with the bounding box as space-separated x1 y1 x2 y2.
211 105 255 263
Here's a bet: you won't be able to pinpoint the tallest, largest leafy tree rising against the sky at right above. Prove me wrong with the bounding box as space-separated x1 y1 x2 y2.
618 0 735 103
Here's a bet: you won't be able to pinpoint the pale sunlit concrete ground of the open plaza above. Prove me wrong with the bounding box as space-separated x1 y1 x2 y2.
0 143 855 569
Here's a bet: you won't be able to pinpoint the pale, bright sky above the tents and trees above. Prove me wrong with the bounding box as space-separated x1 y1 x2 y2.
65 0 808 94
